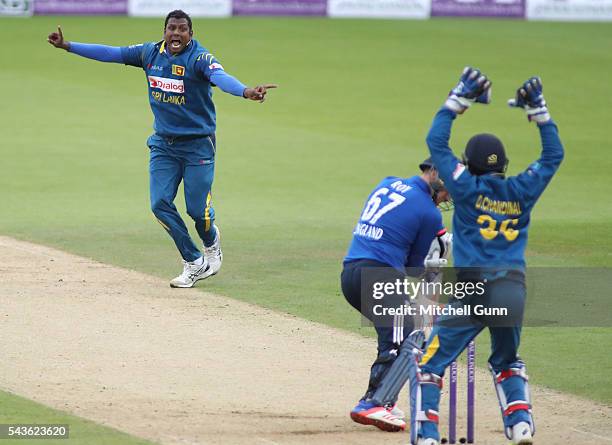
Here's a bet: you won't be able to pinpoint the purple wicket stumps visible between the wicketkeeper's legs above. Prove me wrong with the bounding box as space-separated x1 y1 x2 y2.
441 340 476 444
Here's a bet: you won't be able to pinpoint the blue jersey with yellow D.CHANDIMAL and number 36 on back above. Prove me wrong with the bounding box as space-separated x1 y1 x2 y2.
427 108 563 270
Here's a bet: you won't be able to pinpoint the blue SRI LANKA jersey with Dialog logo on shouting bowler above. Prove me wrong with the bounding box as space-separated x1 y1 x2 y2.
121 39 223 137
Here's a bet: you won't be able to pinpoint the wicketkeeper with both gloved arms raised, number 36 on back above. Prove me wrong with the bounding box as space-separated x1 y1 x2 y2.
410 67 563 445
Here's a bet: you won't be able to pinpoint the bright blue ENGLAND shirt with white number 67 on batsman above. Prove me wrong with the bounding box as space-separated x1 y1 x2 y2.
344 176 443 272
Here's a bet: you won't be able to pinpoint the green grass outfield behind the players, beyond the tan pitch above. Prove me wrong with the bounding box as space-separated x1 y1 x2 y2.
0 17 612 430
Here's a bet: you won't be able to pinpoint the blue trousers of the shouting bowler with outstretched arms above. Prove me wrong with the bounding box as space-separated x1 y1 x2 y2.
147 135 216 261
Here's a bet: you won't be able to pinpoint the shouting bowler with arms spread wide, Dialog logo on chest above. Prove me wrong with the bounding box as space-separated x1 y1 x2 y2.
47 10 276 287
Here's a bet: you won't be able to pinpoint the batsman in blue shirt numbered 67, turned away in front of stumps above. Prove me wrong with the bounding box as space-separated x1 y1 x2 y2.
341 159 452 431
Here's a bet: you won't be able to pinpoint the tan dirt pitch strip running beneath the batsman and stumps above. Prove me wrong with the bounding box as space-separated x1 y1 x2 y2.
0 237 612 445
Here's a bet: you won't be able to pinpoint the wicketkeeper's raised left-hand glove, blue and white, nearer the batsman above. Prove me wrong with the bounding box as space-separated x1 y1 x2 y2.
444 66 491 114
